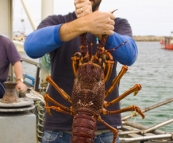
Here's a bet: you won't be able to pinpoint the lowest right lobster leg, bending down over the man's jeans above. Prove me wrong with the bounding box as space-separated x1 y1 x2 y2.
97 116 118 143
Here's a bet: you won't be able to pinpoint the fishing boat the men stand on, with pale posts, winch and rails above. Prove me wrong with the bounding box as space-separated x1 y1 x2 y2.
0 0 173 143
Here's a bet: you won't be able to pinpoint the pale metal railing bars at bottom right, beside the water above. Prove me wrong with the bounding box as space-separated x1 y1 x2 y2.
119 98 173 143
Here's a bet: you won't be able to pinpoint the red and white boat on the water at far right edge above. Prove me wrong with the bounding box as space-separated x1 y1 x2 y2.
160 31 173 50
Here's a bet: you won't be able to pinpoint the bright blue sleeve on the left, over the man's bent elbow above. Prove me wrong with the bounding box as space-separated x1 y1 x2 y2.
24 24 64 58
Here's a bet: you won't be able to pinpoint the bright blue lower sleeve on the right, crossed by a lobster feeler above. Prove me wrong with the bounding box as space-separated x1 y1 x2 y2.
105 32 138 66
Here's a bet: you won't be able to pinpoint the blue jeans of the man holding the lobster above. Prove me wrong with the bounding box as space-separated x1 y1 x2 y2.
42 131 120 143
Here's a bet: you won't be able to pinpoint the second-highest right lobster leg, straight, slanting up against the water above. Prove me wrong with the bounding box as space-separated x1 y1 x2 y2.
104 84 142 107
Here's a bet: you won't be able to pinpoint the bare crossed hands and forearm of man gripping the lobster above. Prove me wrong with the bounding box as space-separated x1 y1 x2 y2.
60 0 115 42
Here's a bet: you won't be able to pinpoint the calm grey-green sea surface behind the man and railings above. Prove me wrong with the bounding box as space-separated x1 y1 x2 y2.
21 42 173 132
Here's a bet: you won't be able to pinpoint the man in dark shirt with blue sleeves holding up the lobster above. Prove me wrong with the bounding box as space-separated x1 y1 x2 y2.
24 0 138 143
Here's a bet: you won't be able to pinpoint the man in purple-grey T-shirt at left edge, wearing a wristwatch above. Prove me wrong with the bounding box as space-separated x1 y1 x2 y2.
0 35 27 98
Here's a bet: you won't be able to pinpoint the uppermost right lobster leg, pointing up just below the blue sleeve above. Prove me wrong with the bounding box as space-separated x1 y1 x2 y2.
105 66 128 98
